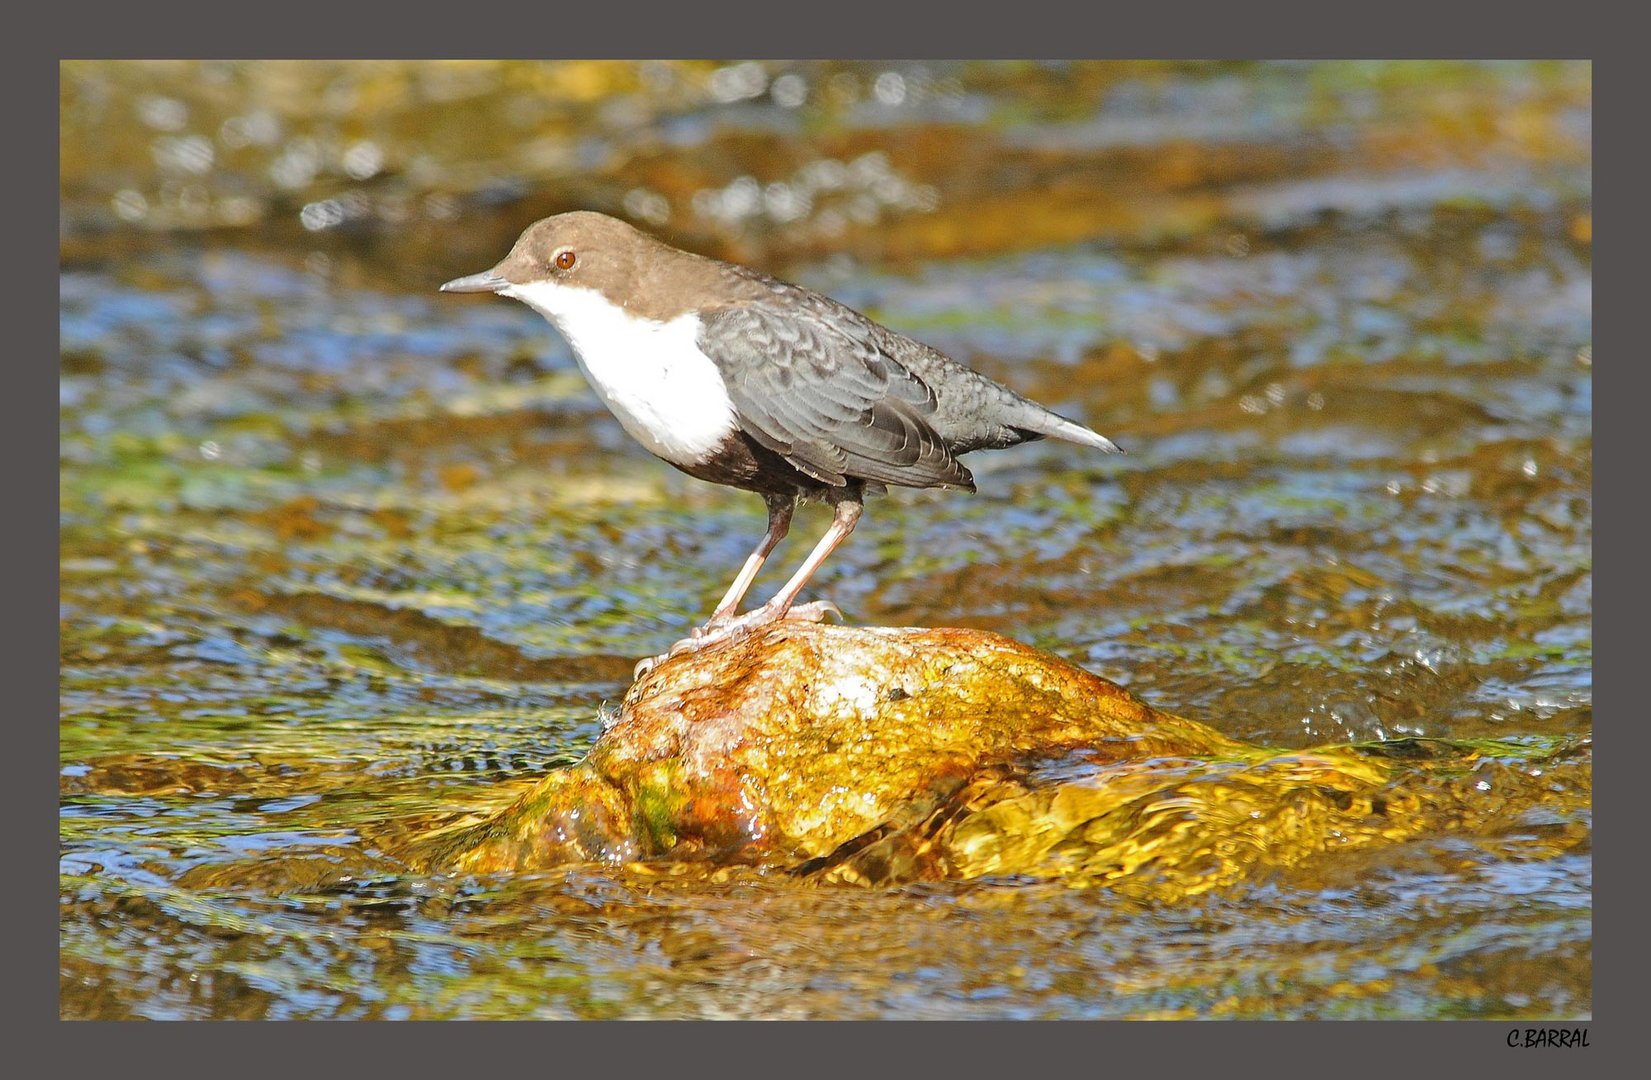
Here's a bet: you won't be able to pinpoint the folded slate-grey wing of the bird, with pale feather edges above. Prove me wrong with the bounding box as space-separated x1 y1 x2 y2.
698 301 974 490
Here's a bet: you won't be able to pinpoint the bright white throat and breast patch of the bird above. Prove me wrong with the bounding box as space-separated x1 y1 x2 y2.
499 281 736 464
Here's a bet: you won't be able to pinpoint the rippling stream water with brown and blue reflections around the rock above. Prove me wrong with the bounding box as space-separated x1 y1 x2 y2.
59 63 1593 1017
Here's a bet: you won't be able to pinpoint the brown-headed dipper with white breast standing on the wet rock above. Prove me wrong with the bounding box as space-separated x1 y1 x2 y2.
441 211 1118 667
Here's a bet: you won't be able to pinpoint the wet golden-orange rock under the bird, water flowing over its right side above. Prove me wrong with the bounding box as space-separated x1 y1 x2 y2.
408 623 1585 897
